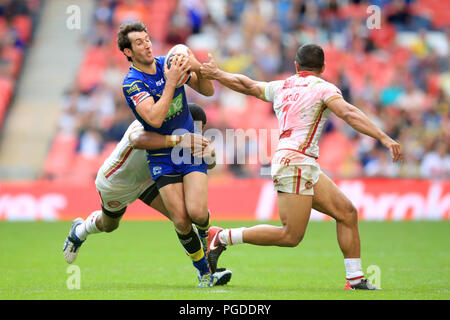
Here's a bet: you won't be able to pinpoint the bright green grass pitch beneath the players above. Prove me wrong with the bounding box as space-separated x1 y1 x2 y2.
0 221 450 300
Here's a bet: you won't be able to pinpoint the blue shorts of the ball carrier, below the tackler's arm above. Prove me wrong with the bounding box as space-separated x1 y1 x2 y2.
147 154 208 181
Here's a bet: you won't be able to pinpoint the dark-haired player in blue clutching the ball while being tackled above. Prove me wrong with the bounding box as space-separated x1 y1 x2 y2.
117 21 215 287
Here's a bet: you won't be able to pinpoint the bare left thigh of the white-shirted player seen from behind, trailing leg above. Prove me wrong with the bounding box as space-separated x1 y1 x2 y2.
278 192 312 241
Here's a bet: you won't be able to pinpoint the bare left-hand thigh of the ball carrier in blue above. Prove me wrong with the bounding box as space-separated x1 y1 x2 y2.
159 182 191 233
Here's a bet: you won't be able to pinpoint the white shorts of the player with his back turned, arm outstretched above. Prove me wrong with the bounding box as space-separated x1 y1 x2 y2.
271 150 322 196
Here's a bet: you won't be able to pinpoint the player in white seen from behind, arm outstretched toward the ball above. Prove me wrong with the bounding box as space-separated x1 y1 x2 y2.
200 44 402 290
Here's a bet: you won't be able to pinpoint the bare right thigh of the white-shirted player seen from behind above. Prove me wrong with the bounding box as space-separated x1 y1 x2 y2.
312 173 357 221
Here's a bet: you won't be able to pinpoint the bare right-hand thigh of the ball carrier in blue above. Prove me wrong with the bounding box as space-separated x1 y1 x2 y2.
183 171 208 222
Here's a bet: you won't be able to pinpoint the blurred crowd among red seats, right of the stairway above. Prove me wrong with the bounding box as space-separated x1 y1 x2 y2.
58 0 450 179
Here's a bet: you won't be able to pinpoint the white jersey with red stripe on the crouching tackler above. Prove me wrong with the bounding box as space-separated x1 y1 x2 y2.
96 120 154 190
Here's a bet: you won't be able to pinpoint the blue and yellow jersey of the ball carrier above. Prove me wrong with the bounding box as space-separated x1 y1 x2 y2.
122 56 194 155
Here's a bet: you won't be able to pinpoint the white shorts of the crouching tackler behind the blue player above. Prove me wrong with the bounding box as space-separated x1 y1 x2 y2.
95 171 155 212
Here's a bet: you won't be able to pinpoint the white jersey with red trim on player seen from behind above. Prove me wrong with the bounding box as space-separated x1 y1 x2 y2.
264 71 342 159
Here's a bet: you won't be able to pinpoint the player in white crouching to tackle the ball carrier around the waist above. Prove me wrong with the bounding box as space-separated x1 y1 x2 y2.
63 103 232 285
